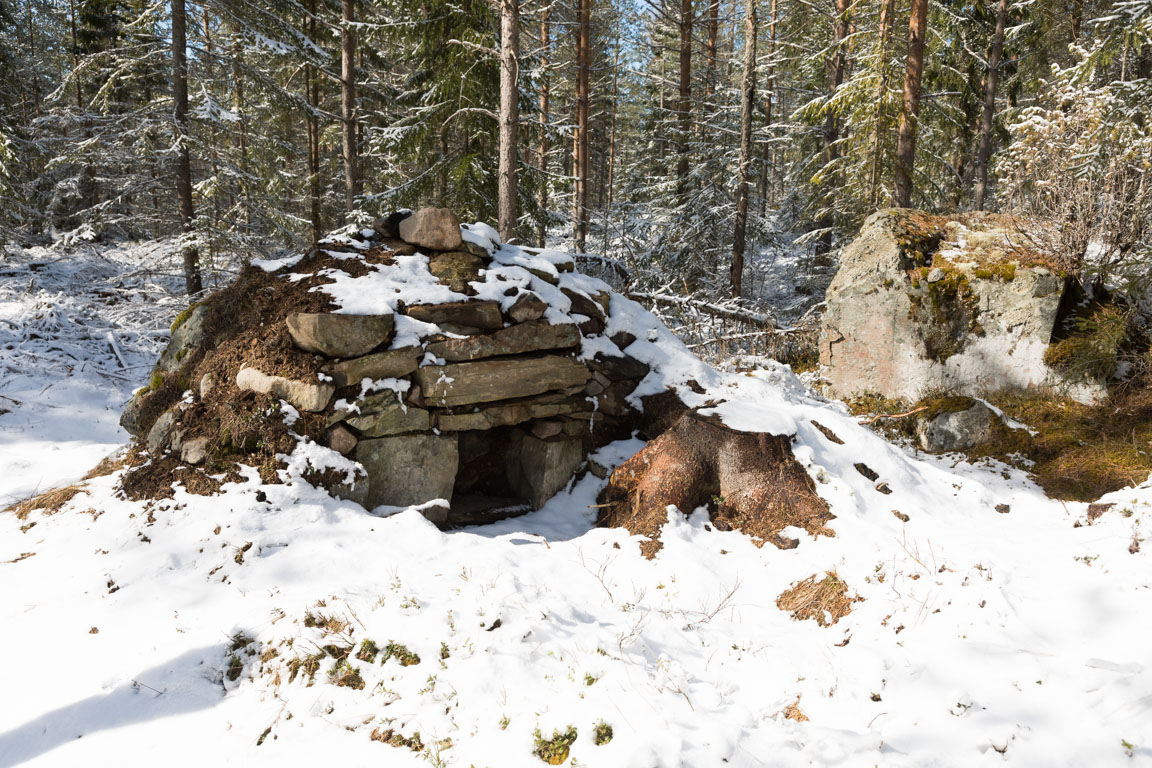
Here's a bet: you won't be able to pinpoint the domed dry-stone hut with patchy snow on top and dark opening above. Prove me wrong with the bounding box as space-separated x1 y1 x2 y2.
122 203 649 526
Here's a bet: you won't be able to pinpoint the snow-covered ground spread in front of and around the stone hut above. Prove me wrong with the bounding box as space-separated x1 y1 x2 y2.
0 241 1152 768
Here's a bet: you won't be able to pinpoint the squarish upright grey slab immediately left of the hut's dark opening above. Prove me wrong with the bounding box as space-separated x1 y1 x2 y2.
353 434 460 509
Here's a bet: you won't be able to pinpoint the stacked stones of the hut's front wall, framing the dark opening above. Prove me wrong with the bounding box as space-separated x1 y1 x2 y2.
236 208 649 524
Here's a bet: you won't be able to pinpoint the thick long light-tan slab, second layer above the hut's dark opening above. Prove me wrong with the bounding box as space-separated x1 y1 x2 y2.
415 355 592 408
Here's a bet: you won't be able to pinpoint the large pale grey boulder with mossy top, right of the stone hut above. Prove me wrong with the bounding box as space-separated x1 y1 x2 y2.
820 210 1102 401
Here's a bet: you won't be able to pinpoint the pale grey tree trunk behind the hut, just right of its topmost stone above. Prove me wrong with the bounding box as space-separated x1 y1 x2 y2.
497 0 520 243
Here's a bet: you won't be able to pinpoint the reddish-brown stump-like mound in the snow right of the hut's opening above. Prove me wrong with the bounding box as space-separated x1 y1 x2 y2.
597 413 834 557
